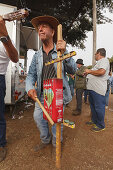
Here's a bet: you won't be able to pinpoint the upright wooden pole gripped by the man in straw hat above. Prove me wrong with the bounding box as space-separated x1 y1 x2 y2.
56 24 62 169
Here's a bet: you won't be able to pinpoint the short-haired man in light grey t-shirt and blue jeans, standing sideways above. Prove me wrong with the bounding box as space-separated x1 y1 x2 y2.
85 48 109 132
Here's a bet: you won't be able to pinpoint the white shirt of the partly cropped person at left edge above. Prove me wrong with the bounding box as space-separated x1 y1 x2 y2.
0 41 10 75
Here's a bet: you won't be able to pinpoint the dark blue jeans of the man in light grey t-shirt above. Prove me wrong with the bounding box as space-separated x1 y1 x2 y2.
89 90 105 129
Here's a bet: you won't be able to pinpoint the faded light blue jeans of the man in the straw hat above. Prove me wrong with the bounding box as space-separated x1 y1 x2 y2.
34 95 63 146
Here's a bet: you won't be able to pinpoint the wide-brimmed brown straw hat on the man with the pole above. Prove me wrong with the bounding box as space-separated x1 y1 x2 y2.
31 15 59 42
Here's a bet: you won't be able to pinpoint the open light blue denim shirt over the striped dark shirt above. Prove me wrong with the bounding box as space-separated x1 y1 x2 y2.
26 44 76 104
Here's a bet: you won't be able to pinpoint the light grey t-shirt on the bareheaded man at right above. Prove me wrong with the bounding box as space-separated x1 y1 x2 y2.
87 58 109 96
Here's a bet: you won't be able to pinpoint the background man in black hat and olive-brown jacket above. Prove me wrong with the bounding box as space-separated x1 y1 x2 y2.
72 59 86 116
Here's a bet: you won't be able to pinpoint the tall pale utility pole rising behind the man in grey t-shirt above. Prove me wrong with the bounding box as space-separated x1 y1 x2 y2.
92 0 97 65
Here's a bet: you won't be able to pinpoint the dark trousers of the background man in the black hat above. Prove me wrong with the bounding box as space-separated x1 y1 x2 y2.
76 89 84 111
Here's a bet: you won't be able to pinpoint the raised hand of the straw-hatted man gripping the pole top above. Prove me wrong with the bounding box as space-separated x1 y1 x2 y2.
56 40 66 54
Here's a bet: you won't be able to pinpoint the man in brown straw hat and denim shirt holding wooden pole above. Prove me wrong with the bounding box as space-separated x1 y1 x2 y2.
26 16 76 151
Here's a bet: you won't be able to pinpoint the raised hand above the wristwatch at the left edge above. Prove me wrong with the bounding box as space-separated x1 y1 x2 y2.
0 16 8 37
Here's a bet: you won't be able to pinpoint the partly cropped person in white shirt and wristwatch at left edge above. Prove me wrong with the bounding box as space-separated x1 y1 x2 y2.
0 16 18 162
